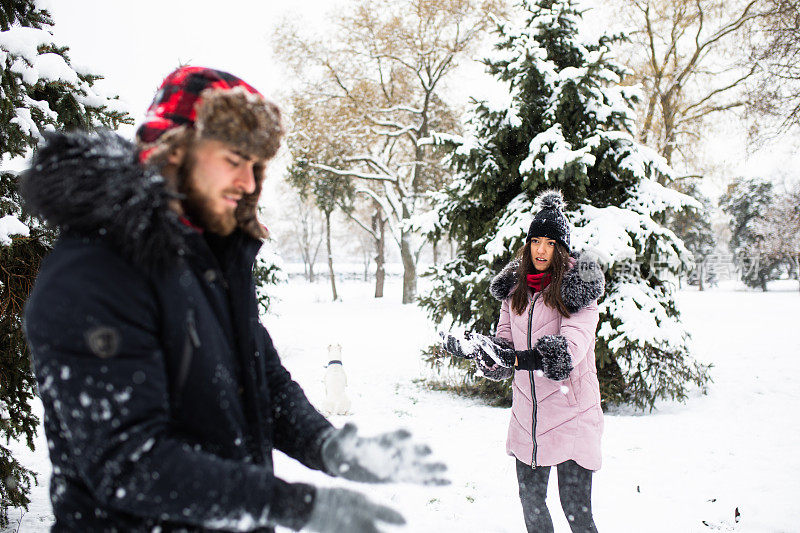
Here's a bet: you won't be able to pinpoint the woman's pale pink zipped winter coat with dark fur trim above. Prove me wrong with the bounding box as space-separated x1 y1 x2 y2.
490 255 604 470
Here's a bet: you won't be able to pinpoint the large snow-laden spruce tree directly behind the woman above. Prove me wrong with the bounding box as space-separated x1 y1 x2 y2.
421 0 709 409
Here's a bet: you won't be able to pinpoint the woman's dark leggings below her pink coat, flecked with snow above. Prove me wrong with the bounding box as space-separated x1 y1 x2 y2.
517 459 597 533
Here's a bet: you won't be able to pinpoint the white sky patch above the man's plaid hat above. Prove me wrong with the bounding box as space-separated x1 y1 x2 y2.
49 0 352 133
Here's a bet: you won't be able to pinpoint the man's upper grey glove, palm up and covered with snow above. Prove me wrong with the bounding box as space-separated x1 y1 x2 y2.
321 423 450 485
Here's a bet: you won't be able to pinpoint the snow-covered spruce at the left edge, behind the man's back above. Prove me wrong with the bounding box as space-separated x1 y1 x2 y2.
0 0 130 527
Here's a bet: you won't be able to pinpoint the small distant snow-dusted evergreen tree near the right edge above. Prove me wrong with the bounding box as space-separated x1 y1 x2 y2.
719 178 782 291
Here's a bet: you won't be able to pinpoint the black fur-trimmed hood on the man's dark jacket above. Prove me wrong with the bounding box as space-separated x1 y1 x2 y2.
20 131 194 272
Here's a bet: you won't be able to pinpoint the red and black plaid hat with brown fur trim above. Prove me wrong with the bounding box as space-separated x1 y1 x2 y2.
136 66 283 162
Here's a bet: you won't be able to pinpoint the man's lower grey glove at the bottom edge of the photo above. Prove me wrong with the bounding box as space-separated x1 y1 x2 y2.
304 488 406 533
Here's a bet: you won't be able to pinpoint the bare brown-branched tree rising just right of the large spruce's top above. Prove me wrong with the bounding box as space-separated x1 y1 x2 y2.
617 0 765 170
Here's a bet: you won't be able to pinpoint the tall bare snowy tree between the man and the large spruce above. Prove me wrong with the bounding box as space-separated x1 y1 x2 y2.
274 0 504 303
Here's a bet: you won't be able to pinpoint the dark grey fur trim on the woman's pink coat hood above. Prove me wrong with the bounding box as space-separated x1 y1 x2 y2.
489 253 605 313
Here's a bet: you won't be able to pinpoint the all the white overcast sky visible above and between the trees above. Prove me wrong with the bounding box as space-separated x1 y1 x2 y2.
45 0 800 200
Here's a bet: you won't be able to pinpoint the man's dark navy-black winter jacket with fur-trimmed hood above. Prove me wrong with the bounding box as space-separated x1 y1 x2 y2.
23 134 331 531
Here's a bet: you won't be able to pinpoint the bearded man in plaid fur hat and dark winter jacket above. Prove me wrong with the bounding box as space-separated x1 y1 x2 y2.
22 67 445 532
